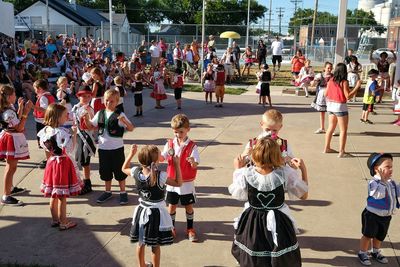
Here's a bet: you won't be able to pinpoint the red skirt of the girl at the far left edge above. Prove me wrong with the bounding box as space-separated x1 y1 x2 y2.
0 131 29 160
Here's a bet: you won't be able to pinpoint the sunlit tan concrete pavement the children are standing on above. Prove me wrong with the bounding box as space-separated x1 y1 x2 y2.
0 88 400 266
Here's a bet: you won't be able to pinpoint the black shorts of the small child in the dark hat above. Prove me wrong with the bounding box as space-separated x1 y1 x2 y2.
361 209 392 241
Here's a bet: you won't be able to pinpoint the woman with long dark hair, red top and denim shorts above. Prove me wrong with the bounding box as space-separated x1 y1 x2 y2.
324 63 357 158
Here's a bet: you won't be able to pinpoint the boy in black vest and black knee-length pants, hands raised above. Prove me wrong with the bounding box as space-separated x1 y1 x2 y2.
85 89 134 205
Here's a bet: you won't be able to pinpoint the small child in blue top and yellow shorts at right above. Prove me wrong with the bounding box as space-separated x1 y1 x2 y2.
360 69 379 124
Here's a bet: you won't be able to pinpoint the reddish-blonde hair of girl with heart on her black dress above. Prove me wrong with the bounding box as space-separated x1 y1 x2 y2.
251 137 284 169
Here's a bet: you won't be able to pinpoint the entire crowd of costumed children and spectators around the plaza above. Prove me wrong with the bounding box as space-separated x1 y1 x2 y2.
0 35 400 267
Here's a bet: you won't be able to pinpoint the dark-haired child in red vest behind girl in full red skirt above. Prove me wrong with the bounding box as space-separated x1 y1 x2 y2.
33 80 56 169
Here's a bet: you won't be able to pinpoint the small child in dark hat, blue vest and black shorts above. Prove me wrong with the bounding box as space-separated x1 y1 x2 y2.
358 153 400 265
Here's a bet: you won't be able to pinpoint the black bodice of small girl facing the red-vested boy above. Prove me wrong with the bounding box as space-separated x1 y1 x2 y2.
133 167 165 202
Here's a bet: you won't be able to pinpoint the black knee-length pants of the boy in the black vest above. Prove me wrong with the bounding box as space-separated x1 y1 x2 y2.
98 147 127 181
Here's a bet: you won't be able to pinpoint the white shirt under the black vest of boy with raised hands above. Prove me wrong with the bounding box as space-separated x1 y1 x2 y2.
90 110 129 150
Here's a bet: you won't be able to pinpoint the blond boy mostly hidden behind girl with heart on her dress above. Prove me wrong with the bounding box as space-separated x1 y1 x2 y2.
242 109 294 165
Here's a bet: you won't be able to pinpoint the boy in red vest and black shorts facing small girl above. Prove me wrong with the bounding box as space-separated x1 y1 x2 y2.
160 114 200 242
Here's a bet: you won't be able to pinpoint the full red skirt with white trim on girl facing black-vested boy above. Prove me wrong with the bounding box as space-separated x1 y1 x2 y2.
40 155 83 198
